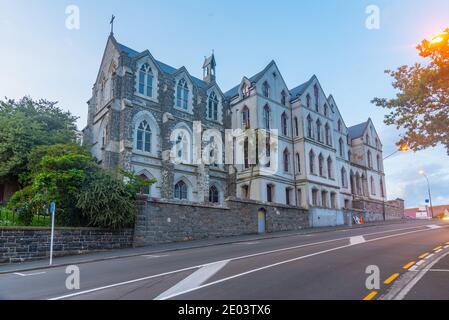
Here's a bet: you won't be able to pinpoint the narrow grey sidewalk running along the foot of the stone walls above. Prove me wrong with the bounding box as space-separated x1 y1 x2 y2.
0 220 410 275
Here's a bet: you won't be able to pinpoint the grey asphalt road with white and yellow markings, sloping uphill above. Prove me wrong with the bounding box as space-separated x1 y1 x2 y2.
0 221 449 300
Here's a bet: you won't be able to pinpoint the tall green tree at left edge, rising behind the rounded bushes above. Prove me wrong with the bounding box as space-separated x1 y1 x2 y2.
0 97 77 182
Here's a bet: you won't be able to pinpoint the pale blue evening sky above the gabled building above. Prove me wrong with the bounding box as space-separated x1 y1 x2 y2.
0 0 449 207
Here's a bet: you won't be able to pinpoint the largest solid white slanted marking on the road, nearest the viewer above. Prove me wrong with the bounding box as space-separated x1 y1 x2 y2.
154 260 229 300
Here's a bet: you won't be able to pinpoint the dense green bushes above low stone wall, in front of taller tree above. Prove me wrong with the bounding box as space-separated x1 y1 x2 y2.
9 144 154 229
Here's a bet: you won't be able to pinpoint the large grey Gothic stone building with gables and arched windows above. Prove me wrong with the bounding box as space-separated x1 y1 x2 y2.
84 34 385 215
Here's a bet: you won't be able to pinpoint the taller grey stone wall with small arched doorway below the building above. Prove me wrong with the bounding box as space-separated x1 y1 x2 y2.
134 198 309 246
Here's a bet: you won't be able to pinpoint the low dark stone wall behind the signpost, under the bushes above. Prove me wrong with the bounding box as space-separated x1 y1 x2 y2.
0 227 133 263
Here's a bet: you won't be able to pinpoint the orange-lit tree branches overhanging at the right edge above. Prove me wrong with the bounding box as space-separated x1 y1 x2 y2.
372 29 449 154
